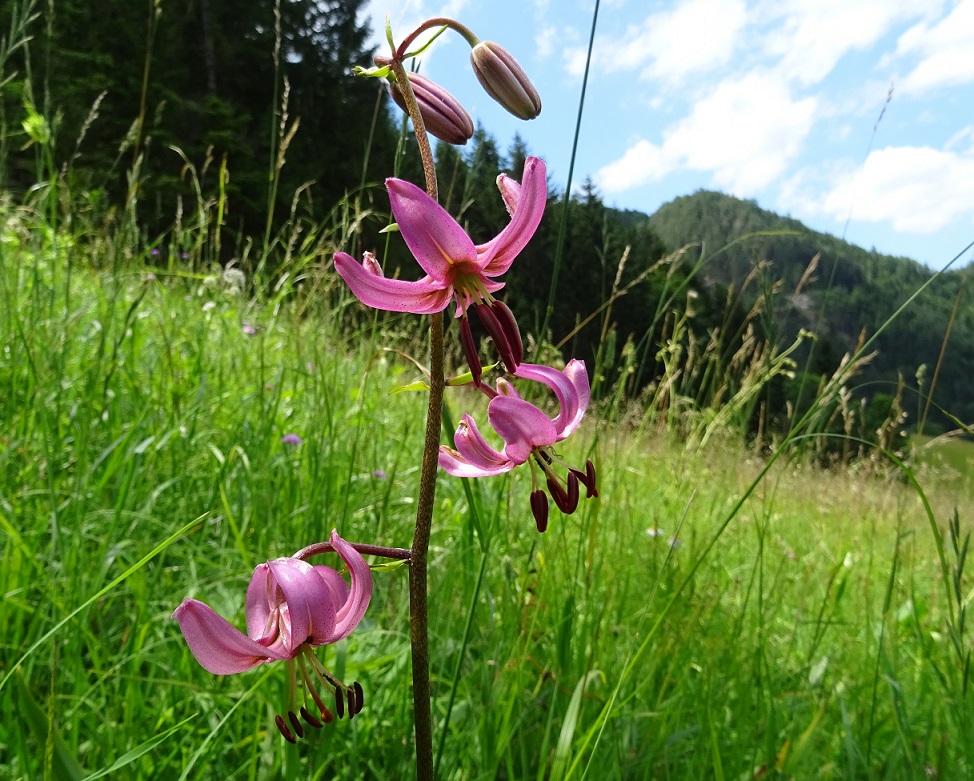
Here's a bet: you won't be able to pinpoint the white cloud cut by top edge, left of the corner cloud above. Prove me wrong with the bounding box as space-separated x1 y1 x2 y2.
754 0 940 85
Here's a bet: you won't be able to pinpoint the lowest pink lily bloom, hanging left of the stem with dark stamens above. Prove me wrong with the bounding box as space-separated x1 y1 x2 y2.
173 531 372 743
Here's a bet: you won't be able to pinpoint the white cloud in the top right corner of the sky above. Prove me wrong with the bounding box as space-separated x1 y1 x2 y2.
896 0 974 93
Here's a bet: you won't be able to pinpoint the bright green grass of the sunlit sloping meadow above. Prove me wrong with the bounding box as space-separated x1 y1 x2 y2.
0 203 974 779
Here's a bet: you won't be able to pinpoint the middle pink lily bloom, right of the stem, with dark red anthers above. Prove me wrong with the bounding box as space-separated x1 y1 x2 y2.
439 360 599 532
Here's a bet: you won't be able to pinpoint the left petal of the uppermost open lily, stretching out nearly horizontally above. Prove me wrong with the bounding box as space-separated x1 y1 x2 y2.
335 252 453 315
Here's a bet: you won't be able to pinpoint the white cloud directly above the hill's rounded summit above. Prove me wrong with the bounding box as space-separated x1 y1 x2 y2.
595 71 818 196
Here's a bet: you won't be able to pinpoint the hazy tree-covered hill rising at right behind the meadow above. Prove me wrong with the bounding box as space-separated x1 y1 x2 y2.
649 190 974 430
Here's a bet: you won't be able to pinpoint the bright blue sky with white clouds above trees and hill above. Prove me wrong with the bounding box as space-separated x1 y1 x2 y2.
368 0 974 268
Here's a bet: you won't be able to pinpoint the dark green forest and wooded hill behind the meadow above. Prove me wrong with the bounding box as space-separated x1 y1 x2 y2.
0 0 974 438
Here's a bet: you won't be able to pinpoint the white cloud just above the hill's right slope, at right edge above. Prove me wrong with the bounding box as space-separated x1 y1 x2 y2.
783 146 974 234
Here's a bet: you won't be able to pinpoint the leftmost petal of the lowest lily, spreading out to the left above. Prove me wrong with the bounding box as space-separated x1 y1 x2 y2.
172 599 283 675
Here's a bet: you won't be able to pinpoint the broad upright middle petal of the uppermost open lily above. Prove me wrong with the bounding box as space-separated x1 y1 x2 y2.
386 179 477 284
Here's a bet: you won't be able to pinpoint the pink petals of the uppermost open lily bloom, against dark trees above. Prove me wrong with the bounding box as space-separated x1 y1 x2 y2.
335 157 548 317
